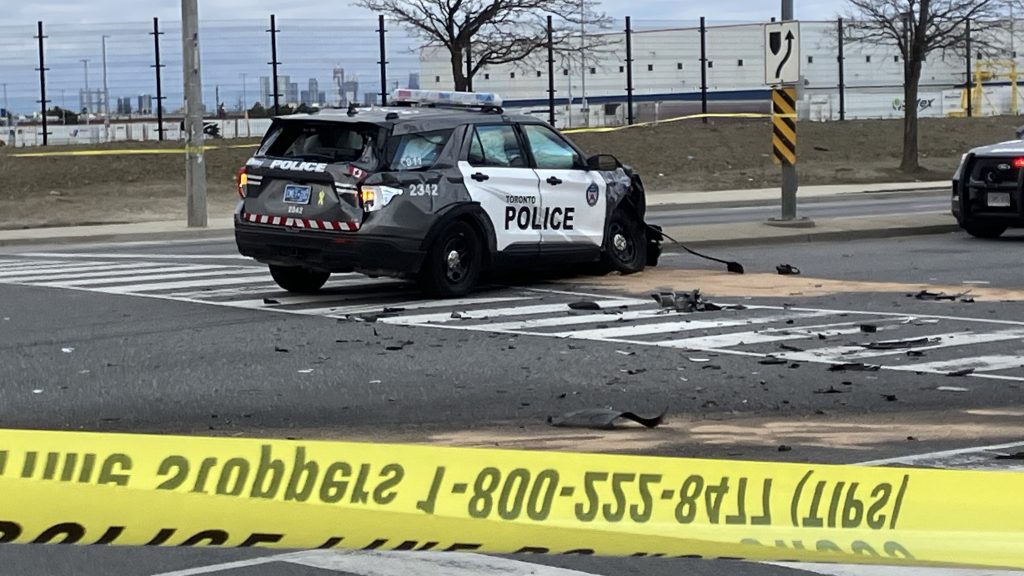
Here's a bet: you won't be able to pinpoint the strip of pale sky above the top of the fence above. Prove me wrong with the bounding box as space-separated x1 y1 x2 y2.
0 0 846 25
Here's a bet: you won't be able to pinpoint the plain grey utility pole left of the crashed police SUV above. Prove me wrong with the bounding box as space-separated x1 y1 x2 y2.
181 0 207 228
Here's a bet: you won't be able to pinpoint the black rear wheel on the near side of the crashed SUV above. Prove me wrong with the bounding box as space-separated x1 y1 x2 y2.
420 221 483 298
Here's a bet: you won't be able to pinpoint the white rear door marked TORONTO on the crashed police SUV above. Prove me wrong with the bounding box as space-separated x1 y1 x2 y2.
459 124 543 253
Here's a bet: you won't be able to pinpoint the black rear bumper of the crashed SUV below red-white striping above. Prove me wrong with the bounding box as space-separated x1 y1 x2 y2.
234 216 425 277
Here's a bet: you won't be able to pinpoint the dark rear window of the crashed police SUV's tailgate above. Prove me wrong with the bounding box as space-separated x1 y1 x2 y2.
257 122 380 162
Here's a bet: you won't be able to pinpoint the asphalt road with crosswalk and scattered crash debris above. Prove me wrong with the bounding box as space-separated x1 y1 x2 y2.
0 226 1024 576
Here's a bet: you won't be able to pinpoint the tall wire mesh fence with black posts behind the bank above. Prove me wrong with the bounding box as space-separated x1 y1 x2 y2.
0 16 1019 147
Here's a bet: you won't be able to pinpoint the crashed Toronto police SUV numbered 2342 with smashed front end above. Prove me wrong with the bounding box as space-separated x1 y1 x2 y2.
234 90 662 296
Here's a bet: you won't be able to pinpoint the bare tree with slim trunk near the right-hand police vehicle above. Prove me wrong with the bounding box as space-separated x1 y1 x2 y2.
847 0 1006 172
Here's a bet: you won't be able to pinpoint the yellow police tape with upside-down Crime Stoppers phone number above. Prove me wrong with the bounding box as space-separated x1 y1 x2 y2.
0 430 1024 568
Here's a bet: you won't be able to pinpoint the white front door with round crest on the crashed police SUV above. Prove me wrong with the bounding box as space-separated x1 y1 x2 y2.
522 124 607 250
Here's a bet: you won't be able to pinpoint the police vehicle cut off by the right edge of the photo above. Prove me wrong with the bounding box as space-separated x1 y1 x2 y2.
951 133 1024 238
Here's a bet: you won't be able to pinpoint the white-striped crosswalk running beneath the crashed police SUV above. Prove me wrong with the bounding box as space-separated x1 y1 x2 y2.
0 253 1024 381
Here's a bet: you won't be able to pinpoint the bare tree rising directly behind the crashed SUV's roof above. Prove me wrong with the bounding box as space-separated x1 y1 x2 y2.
353 0 610 90
